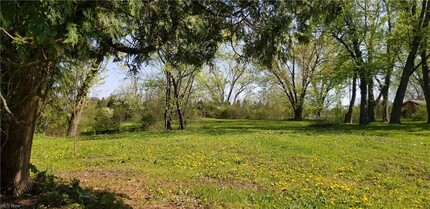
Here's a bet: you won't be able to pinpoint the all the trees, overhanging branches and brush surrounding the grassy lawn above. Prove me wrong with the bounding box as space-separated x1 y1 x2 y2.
0 0 430 198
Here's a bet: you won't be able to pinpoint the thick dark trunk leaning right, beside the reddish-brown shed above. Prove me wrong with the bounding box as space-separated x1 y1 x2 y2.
390 42 419 124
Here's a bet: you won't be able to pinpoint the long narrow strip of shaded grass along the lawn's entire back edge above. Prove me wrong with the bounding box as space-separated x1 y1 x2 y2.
76 119 430 140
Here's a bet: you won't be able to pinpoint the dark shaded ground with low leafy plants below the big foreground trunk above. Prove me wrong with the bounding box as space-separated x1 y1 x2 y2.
2 165 132 209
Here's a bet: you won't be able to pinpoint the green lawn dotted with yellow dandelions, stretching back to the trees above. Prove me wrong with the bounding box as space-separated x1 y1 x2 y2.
31 119 430 208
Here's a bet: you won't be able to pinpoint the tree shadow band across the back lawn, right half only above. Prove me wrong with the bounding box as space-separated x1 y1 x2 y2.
199 120 430 136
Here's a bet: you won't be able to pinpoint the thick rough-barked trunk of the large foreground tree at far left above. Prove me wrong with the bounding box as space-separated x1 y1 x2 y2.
0 66 44 196
